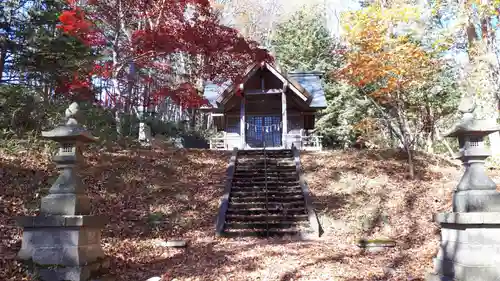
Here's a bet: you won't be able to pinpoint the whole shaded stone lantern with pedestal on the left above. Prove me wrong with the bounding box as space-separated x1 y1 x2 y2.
17 103 108 281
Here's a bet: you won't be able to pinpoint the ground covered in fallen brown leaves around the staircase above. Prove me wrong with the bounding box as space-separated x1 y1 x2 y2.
0 145 488 281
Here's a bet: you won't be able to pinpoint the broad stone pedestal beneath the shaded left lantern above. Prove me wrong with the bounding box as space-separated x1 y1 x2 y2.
17 215 109 281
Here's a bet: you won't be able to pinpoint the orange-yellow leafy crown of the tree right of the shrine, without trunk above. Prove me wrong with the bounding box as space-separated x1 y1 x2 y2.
338 6 436 105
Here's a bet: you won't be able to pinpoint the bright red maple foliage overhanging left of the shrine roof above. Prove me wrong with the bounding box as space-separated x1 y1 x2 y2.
59 0 272 107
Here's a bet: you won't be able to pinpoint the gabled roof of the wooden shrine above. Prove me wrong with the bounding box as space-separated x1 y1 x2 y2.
203 63 327 109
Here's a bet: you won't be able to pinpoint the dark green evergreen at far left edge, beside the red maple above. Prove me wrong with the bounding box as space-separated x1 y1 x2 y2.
0 0 95 137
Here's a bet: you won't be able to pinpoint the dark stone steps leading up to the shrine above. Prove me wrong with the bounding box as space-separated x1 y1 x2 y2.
218 150 311 237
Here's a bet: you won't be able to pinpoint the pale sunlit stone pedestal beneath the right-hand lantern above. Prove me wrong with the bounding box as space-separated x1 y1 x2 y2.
427 212 500 281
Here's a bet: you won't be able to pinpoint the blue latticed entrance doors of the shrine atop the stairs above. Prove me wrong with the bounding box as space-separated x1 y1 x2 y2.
245 116 282 148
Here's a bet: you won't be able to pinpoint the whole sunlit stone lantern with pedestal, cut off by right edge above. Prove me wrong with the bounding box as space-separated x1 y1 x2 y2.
427 112 500 281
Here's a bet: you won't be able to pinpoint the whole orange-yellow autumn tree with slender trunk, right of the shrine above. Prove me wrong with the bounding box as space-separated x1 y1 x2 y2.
335 4 441 177
